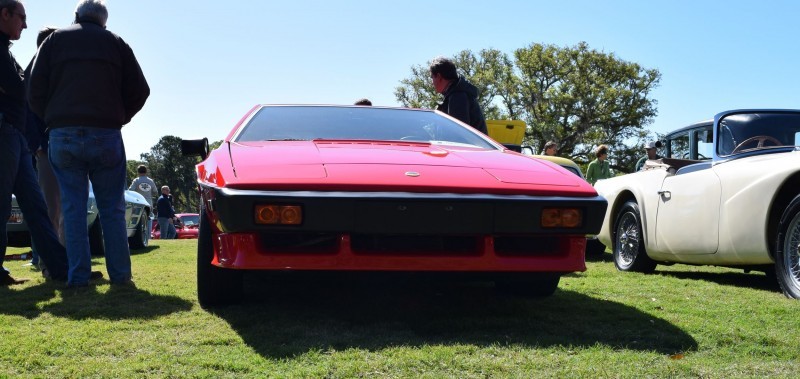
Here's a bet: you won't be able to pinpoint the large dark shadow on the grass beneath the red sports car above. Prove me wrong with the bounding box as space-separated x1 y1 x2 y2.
212 278 697 358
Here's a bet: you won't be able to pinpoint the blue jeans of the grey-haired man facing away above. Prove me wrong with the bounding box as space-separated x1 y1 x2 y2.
45 126 131 286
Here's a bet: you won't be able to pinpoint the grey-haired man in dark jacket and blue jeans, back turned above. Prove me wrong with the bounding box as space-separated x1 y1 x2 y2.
28 0 150 287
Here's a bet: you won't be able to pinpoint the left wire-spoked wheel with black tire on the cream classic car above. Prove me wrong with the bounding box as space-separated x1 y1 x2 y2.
614 201 657 273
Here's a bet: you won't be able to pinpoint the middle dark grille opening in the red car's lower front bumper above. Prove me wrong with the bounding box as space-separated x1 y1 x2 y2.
350 234 482 256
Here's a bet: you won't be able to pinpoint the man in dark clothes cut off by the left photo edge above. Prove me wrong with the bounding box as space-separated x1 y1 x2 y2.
0 0 69 286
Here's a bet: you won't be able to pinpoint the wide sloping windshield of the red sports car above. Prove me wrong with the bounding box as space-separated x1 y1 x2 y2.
231 106 497 150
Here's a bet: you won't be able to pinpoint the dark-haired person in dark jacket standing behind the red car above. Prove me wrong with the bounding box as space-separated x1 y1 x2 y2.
430 57 488 134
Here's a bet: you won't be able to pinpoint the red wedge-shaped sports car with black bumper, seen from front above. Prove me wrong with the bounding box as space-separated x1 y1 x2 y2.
182 105 606 306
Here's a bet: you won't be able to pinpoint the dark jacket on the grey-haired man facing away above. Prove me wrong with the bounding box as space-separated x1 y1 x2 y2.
29 22 150 128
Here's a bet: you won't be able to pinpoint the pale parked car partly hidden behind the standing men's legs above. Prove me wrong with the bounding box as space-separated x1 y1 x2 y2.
6 190 151 255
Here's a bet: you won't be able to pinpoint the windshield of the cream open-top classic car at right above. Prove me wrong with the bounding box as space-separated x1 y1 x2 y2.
717 111 800 156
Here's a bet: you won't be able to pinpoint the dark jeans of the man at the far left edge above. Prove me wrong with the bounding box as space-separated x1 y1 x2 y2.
0 124 69 280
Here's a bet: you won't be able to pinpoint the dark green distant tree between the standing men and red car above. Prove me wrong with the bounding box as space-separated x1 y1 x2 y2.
141 136 200 212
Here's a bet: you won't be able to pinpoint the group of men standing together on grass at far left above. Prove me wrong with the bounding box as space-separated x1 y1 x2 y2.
0 0 150 287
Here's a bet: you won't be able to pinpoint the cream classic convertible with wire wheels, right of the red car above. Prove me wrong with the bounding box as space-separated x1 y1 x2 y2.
595 110 800 299
